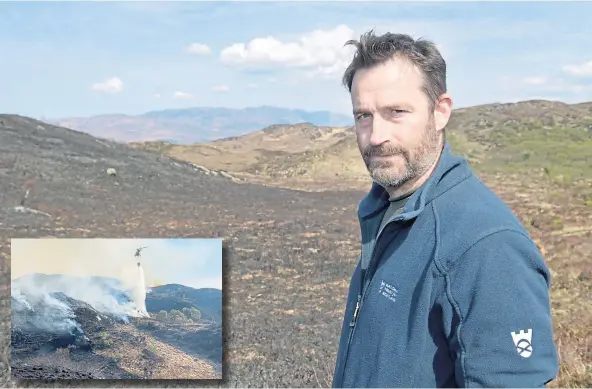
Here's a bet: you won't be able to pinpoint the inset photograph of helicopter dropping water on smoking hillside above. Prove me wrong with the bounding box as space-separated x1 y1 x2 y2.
11 238 222 380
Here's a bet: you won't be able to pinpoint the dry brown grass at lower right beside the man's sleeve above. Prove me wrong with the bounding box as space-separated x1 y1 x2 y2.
483 174 592 387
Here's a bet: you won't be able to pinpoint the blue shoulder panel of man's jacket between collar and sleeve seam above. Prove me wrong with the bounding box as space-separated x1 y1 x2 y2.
431 175 534 269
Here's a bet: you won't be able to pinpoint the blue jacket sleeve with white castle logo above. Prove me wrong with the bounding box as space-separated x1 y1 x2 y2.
446 230 559 388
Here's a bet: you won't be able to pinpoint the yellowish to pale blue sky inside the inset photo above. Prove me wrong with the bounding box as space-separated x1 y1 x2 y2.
11 238 222 289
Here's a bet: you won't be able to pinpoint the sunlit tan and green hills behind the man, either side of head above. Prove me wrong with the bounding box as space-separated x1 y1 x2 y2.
134 100 592 187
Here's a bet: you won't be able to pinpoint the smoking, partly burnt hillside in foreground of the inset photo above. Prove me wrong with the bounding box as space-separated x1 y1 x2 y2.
10 274 222 379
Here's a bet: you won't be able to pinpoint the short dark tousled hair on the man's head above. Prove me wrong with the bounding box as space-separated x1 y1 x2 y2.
343 30 446 109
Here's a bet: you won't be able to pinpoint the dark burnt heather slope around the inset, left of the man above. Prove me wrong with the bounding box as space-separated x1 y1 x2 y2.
0 115 363 387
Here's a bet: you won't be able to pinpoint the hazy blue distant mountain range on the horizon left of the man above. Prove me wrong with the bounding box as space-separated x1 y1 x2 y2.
45 106 353 144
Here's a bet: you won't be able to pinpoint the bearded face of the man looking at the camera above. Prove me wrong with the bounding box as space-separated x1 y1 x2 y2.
351 59 449 188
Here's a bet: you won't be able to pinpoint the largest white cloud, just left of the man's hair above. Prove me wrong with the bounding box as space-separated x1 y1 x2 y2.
220 24 354 76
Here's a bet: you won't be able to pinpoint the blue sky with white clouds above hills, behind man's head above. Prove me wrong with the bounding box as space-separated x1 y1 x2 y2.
0 1 592 119
